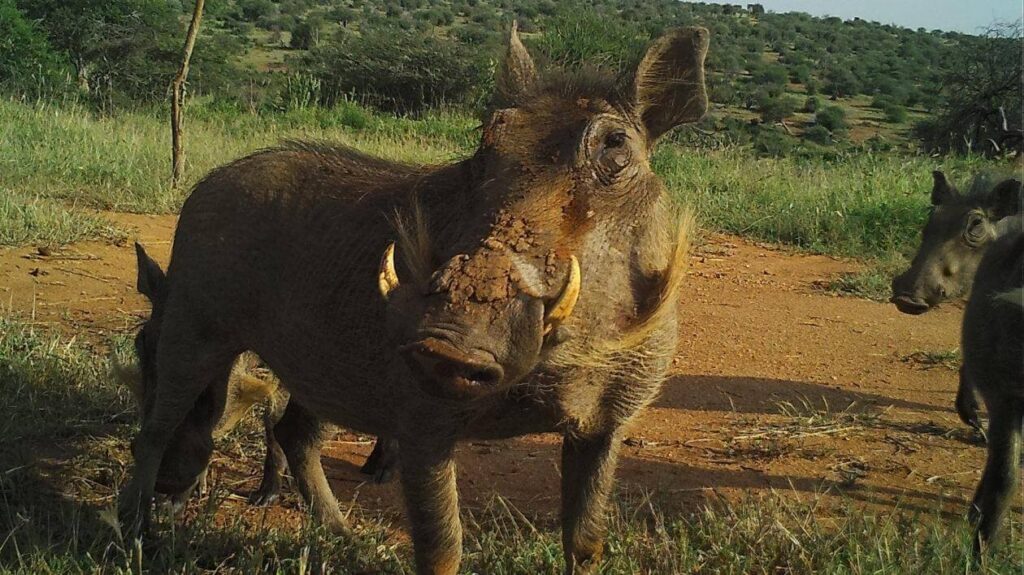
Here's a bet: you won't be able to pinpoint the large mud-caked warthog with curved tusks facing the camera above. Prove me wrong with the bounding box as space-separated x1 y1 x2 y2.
119 23 708 573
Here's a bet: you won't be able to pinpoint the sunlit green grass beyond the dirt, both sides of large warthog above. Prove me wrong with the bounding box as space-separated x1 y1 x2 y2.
0 96 1007 288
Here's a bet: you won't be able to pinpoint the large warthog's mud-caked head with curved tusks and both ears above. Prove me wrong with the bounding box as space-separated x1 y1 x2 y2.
380 27 709 400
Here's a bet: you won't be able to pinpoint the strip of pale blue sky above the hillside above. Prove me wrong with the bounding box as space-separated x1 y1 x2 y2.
706 0 1024 34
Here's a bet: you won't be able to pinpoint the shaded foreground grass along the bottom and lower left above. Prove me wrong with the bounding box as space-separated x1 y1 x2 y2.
0 318 1024 575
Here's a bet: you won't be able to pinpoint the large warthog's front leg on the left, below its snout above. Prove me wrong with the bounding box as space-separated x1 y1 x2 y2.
398 438 462 575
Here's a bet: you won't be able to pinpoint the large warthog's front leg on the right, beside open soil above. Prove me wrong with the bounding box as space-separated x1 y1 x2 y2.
562 433 620 575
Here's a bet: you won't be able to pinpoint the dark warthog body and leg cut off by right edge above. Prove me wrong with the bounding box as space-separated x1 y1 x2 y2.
961 223 1024 555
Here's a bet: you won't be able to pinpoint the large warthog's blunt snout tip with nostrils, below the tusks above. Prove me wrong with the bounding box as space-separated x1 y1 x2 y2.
400 338 505 399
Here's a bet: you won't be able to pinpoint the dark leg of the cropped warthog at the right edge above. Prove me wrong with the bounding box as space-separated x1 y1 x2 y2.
968 398 1024 555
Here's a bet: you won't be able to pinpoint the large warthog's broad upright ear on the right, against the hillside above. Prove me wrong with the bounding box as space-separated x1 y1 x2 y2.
634 28 710 142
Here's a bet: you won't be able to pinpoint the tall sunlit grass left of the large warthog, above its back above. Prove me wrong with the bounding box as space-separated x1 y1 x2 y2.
0 100 475 213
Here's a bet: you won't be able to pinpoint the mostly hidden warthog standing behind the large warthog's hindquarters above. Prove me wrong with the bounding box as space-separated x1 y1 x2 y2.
114 244 396 525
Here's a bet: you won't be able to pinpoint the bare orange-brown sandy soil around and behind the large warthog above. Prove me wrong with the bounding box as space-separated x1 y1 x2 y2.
0 214 1021 532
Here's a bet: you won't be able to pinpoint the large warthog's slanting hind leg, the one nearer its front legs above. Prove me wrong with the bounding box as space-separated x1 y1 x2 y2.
267 399 350 535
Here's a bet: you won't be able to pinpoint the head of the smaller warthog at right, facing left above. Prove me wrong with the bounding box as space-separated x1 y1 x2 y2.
892 172 1022 314
